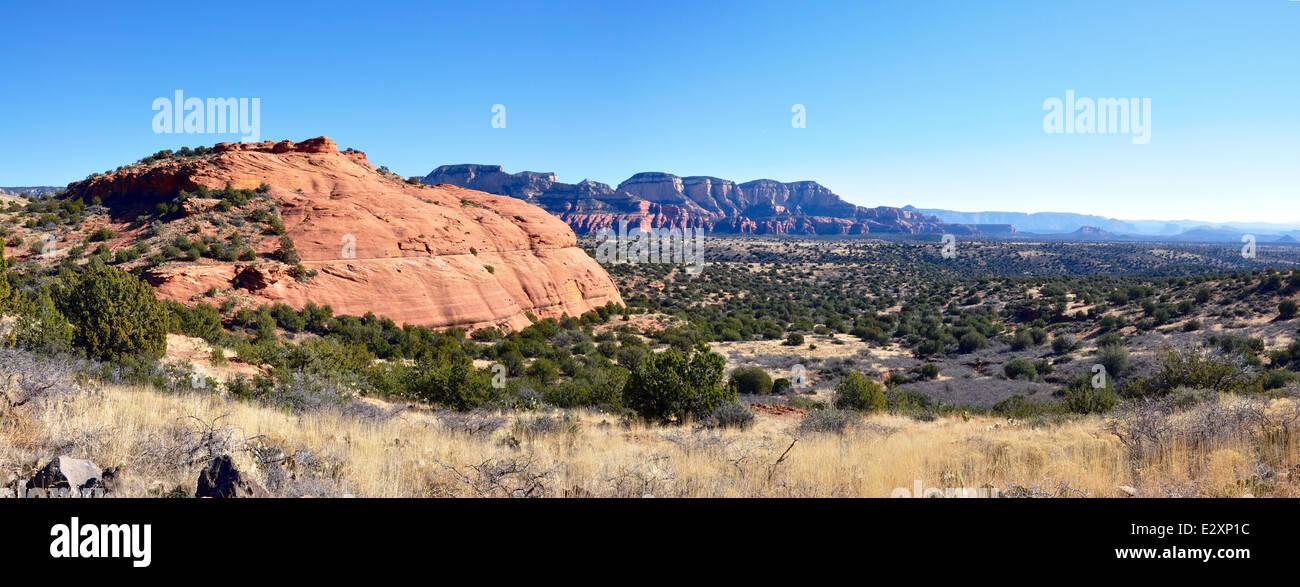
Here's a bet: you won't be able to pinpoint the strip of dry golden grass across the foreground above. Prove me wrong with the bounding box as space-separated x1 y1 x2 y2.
0 387 1300 497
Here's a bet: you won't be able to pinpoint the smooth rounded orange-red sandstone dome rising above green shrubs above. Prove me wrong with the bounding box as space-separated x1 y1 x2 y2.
72 136 623 329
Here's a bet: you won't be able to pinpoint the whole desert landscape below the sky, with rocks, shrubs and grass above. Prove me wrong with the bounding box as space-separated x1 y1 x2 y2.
0 136 1300 497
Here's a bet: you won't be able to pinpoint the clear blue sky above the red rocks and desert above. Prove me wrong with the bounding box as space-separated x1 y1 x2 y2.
0 0 1300 221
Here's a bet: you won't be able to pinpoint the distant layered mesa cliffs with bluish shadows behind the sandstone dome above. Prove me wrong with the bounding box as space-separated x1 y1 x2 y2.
423 165 979 235
